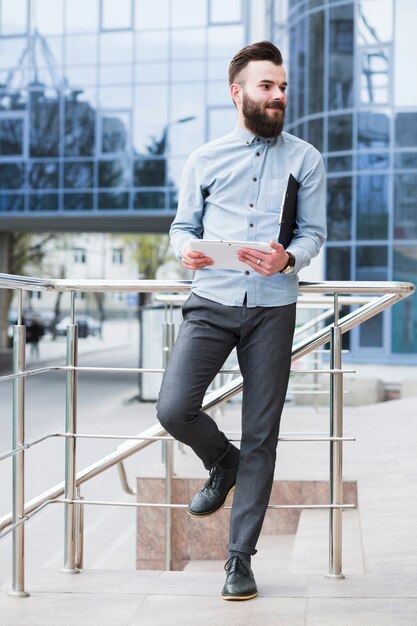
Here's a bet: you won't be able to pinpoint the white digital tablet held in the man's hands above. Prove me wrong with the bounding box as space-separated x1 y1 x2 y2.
188 239 272 270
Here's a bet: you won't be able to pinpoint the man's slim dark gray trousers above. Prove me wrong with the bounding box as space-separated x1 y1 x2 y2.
158 294 296 555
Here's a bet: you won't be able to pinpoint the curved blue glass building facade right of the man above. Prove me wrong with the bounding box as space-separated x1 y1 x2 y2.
272 0 417 363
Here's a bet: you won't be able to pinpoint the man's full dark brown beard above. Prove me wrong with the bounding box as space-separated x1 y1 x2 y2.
242 93 285 137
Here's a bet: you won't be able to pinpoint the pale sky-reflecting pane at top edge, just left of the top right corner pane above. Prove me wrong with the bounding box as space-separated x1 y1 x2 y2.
358 0 392 44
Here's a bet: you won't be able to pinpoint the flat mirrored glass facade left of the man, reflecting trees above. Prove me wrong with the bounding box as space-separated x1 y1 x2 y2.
0 0 248 231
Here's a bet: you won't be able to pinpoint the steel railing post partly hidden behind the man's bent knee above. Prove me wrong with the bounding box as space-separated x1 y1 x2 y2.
162 305 175 571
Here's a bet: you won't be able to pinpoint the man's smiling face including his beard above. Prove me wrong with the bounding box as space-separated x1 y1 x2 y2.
236 61 287 137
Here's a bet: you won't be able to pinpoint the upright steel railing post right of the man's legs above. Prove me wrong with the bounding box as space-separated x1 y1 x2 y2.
327 294 344 578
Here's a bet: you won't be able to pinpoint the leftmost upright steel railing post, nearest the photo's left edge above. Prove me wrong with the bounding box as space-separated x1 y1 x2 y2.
9 290 30 598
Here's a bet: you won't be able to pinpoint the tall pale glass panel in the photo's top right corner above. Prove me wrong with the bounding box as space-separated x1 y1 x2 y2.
394 0 417 106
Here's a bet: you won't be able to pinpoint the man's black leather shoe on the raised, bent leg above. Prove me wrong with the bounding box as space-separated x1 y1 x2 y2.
188 466 238 517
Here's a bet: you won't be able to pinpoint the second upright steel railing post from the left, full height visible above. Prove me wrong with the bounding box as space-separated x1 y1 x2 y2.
61 292 80 574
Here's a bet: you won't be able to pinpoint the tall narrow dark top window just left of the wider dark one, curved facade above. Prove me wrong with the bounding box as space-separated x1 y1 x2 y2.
308 11 324 113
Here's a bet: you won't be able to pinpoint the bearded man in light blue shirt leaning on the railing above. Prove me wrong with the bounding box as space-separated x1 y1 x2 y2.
158 41 326 600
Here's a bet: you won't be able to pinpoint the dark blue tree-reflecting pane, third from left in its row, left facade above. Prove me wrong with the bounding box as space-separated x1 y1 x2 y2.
64 98 96 156
